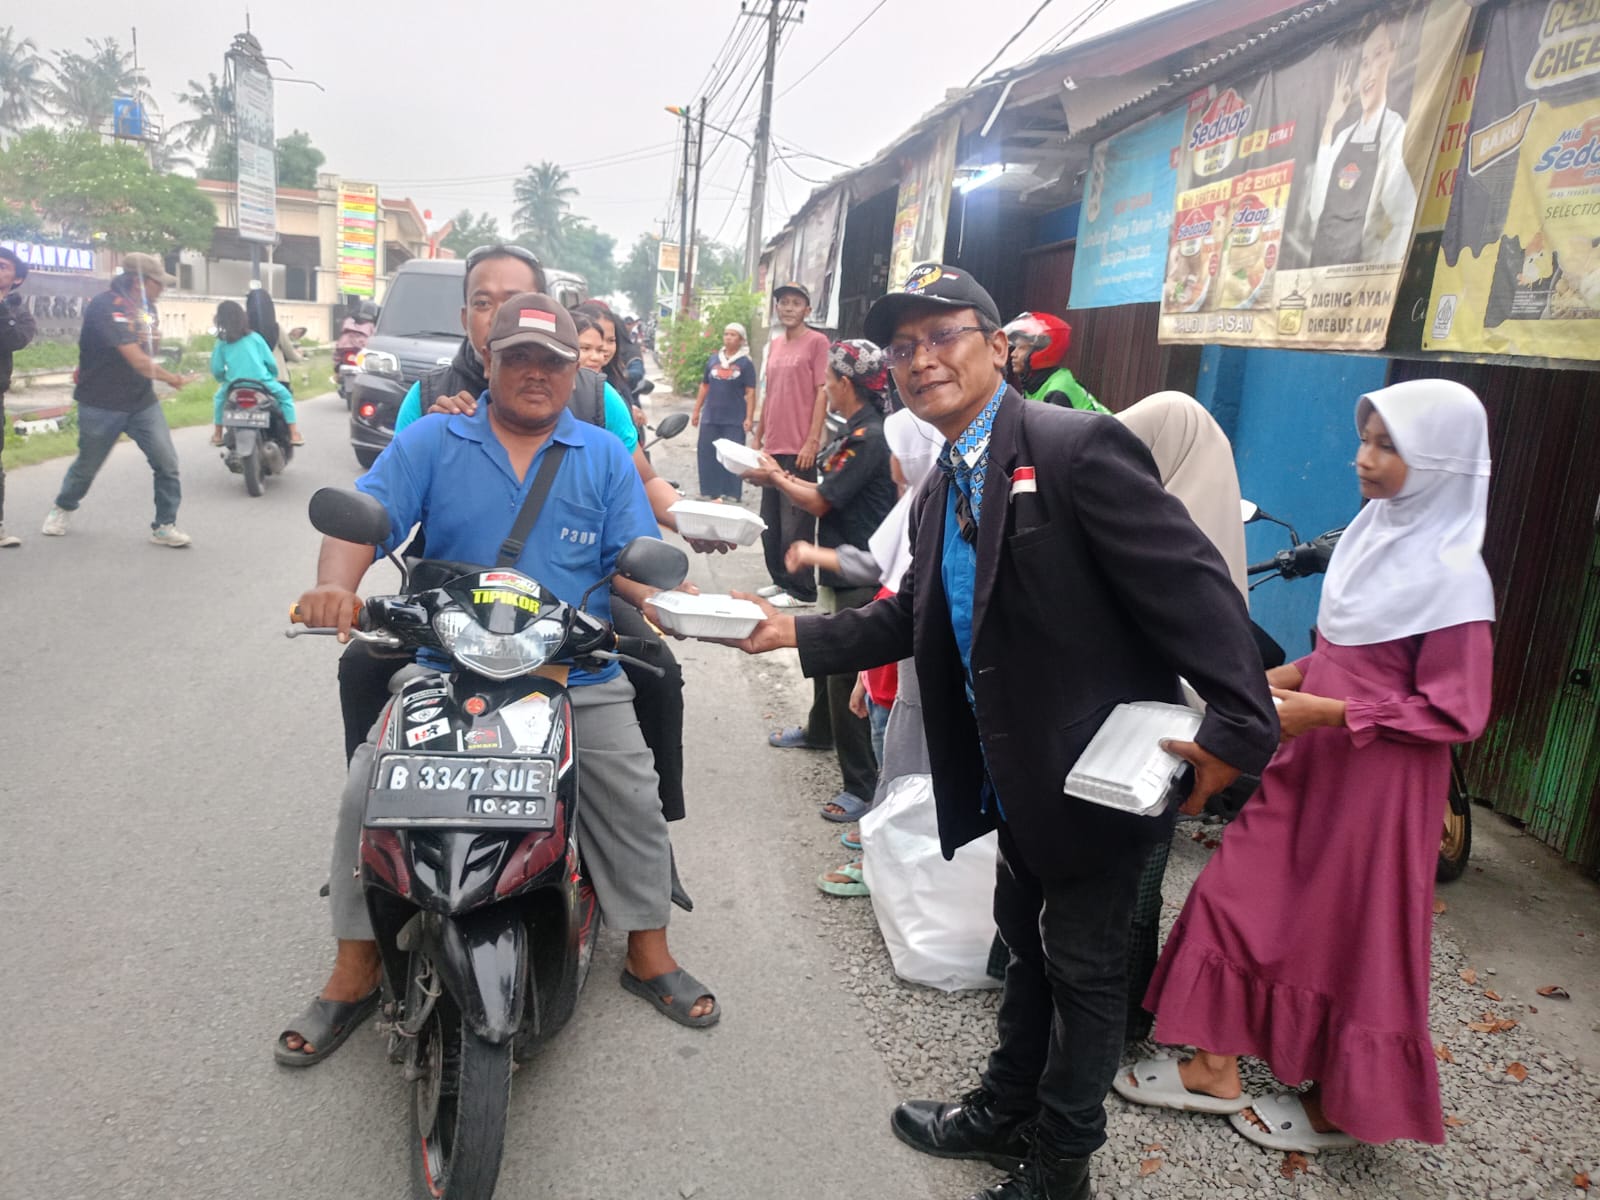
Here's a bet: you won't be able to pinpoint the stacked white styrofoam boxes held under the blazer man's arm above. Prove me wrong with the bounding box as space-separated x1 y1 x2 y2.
1062 701 1205 816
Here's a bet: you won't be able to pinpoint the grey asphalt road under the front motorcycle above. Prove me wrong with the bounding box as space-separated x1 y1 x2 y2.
0 397 986 1200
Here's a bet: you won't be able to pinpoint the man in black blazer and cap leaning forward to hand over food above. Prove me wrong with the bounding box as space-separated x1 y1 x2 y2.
742 264 1278 1200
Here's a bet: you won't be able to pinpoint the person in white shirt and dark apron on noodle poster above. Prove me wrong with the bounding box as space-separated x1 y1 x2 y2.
1307 19 1416 267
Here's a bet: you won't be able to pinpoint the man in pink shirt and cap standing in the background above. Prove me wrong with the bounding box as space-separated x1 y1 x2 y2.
755 283 829 608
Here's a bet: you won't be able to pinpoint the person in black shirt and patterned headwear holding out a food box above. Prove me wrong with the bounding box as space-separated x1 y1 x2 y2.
747 341 896 822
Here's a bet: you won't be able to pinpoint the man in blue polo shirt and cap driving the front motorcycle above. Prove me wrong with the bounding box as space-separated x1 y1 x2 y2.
277 293 722 1066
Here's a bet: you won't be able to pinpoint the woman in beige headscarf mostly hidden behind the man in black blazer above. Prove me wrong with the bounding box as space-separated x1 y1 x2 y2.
1117 392 1248 1042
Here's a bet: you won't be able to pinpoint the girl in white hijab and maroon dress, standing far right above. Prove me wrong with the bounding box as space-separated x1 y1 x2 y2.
1117 379 1494 1152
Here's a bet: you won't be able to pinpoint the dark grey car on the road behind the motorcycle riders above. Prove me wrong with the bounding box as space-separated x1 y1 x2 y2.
350 259 467 467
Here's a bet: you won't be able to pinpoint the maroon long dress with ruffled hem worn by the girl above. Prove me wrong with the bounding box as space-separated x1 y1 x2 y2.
1144 621 1491 1142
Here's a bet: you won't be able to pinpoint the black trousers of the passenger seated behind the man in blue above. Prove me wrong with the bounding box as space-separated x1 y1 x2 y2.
339 597 684 821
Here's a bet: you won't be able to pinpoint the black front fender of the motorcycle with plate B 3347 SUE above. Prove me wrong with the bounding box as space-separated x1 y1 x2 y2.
422 907 528 1046
